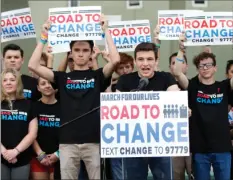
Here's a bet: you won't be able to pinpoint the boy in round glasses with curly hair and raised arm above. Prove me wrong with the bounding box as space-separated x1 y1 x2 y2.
174 36 233 180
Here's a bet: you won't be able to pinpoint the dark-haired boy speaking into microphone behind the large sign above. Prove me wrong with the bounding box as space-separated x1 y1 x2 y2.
116 42 179 180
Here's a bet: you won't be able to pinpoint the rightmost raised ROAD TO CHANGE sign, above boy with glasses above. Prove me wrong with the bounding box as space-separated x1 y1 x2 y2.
184 12 233 46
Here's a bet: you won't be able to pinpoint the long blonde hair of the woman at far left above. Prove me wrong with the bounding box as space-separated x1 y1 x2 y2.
1 69 24 101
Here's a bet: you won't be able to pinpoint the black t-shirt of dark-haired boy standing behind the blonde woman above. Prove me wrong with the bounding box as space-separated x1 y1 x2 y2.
21 74 41 101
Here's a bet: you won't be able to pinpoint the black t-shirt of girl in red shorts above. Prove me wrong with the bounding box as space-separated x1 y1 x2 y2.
34 101 60 154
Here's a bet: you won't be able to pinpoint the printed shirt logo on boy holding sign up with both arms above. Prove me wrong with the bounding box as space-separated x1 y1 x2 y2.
66 77 95 89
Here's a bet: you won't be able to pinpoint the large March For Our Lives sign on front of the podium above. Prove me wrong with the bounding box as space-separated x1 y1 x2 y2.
100 91 189 158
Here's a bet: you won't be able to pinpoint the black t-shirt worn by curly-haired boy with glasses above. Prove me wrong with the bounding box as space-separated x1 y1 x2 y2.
188 76 231 153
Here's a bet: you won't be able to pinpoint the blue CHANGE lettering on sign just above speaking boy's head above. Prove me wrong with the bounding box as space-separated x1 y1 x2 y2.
113 35 151 45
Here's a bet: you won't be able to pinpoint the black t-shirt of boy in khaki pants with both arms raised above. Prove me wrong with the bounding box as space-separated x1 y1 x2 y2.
54 68 111 144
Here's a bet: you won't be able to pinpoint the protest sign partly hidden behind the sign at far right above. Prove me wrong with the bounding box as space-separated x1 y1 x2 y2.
158 10 202 40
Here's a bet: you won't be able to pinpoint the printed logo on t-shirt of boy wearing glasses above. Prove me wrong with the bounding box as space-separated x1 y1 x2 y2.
197 91 223 104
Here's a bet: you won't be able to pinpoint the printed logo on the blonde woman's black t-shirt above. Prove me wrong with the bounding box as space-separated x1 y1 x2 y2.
1 109 27 121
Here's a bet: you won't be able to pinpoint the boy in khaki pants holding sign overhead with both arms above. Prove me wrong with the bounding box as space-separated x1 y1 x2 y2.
28 17 120 179
